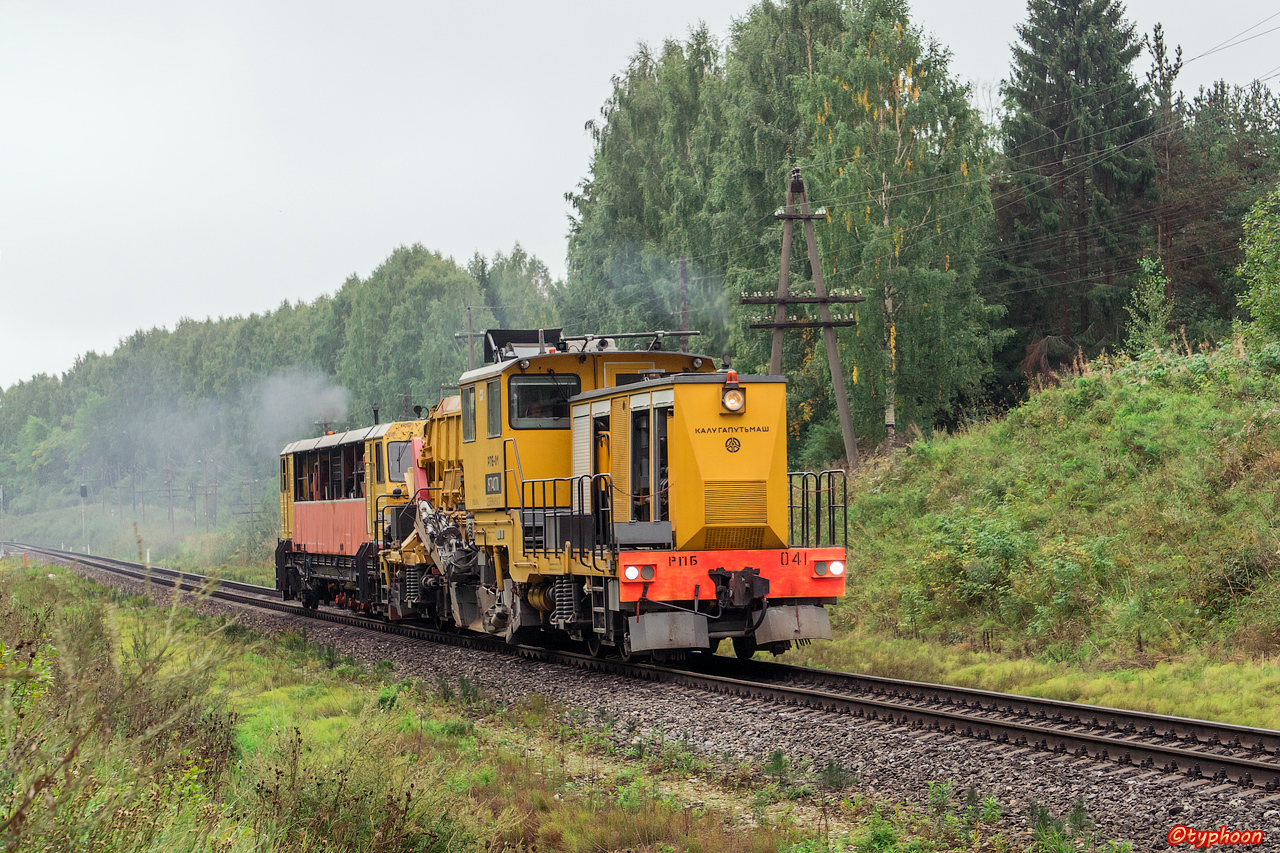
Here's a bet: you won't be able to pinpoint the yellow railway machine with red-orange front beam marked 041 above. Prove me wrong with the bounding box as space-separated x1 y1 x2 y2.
285 330 847 657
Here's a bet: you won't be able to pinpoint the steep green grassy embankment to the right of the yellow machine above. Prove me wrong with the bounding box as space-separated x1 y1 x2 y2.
787 341 1280 729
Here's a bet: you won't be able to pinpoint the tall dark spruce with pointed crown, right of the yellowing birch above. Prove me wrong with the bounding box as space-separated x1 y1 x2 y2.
1000 0 1153 345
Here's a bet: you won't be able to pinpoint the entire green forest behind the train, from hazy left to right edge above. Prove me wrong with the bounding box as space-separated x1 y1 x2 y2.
0 0 1280 560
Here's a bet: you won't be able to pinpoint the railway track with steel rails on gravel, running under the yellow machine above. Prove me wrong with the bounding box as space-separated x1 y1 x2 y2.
10 543 1280 794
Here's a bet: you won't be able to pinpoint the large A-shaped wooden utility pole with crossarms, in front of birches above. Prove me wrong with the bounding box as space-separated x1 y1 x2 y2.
739 169 867 467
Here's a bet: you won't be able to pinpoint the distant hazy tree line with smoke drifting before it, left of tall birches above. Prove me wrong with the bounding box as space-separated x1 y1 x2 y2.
0 245 553 517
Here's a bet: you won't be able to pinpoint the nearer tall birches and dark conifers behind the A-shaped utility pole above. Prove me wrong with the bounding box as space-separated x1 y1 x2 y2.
564 0 1280 465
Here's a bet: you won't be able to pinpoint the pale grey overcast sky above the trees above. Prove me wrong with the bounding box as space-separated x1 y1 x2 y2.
0 0 1280 387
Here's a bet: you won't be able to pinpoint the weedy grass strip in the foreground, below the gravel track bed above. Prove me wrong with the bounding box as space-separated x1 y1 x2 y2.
0 560 1034 853
